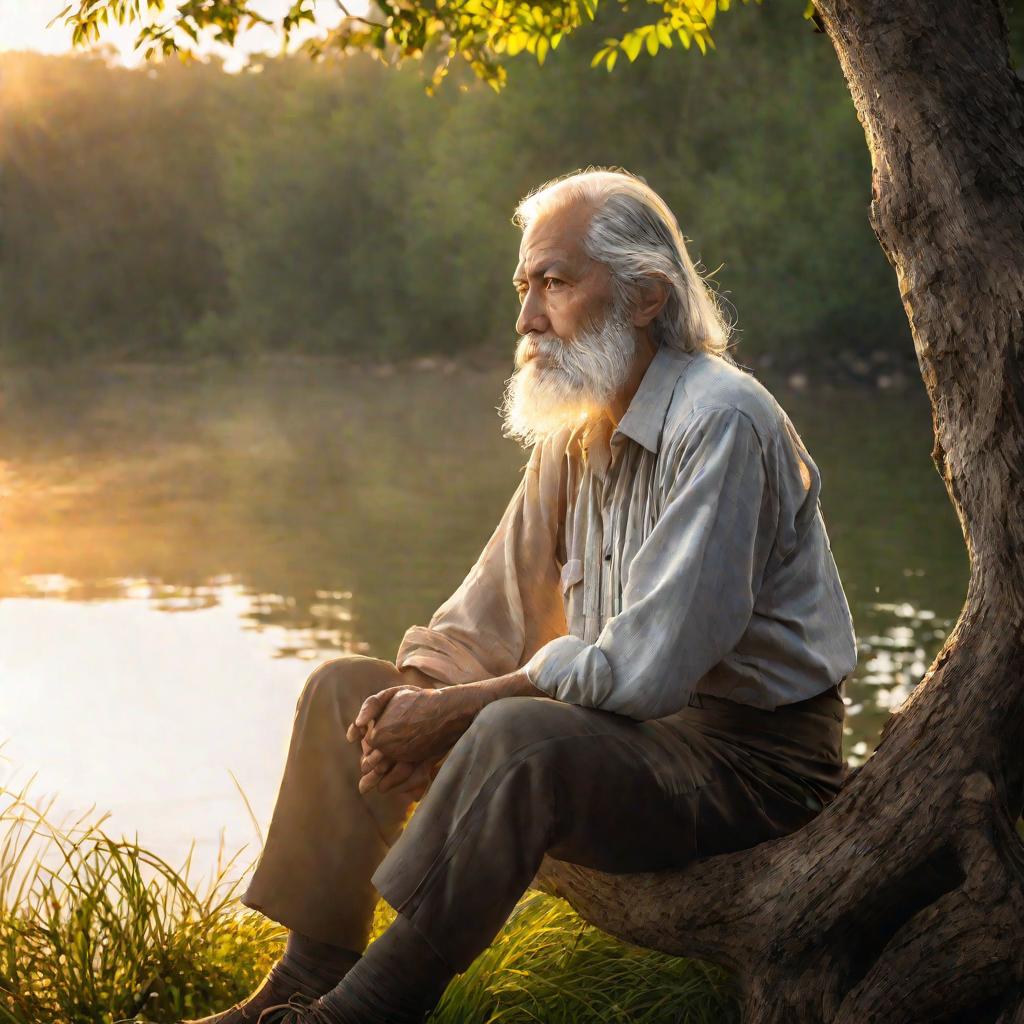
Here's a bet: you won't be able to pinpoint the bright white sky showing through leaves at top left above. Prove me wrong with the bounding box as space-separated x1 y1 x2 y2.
0 0 352 71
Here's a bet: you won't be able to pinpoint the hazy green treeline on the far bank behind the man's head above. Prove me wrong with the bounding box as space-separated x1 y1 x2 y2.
0 0 909 364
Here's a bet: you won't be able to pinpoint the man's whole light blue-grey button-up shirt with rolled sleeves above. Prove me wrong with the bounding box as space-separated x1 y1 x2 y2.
396 348 856 721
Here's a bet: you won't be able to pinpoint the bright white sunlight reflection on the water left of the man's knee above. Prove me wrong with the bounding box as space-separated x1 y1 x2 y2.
0 580 352 876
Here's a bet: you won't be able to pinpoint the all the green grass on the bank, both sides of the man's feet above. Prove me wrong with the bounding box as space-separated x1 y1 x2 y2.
0 790 738 1024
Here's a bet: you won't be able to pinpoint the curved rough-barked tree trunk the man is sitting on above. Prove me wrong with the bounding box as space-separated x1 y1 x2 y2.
540 0 1024 1024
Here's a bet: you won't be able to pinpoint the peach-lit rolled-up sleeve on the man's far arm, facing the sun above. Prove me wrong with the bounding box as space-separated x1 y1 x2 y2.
395 435 567 683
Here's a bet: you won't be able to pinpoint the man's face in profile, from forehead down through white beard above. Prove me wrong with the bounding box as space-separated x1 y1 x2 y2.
502 197 637 444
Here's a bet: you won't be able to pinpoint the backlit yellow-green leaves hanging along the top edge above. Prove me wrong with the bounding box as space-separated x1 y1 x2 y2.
54 0 814 90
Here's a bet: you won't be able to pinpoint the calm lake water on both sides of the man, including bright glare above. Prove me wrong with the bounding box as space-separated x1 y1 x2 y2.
0 362 967 864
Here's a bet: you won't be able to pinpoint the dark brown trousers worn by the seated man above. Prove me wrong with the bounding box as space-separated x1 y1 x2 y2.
242 655 844 971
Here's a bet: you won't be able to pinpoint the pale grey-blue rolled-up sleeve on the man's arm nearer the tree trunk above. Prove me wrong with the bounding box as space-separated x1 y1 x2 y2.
524 408 777 721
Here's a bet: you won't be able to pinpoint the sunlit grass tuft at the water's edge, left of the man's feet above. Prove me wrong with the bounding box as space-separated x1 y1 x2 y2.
0 786 285 1024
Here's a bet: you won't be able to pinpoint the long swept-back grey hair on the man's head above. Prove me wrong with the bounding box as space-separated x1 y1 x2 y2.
512 167 731 358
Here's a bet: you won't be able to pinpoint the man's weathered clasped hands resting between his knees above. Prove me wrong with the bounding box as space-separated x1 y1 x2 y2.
346 683 474 800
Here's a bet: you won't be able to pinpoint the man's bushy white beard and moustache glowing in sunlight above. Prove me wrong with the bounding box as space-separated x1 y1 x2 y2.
500 310 637 447
